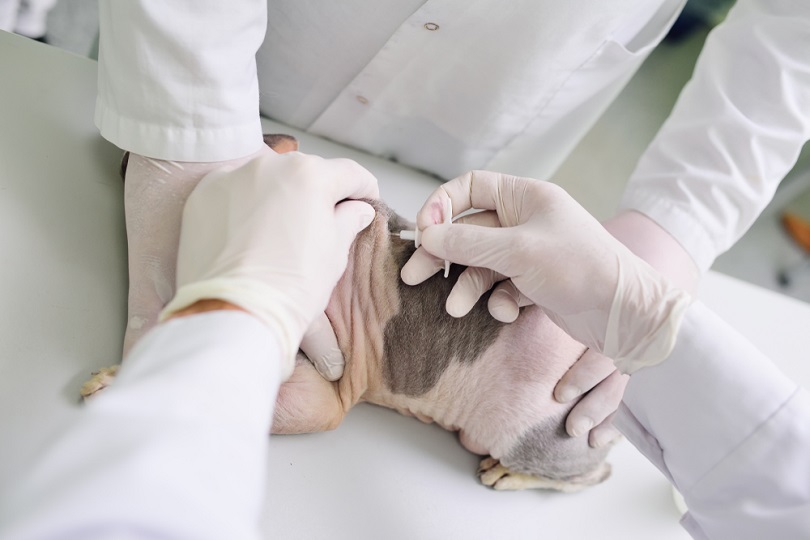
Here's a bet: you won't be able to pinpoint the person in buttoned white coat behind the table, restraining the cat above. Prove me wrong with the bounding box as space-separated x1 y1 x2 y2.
96 0 810 446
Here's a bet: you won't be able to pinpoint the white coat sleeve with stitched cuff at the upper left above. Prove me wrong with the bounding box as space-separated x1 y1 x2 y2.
95 0 267 162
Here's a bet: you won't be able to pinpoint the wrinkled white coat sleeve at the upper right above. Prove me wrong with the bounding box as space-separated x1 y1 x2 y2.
621 0 810 270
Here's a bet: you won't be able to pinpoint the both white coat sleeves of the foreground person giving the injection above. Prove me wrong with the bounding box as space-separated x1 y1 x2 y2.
0 304 810 540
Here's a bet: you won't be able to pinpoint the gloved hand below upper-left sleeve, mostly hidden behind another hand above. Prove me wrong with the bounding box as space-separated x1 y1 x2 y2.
123 141 344 381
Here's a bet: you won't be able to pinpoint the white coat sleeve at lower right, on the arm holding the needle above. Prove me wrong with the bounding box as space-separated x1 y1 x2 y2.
616 303 810 540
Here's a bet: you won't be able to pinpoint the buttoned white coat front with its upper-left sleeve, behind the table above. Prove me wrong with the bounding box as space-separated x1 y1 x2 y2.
96 0 685 170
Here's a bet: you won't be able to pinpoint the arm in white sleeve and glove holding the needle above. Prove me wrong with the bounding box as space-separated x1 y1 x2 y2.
402 171 810 539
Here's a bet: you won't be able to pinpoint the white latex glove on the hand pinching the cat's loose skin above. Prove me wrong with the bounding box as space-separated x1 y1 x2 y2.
160 152 379 379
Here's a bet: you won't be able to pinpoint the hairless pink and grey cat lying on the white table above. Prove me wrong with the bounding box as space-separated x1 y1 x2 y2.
82 135 610 491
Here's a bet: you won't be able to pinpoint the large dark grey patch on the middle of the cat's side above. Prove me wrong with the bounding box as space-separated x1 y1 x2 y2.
382 214 504 396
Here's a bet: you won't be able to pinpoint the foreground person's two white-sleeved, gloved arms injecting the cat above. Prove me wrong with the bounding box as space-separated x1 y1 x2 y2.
0 158 810 540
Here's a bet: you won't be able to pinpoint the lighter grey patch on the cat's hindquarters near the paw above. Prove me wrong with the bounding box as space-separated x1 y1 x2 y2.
501 410 611 484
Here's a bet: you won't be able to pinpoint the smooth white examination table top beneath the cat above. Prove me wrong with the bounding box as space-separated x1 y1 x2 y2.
0 32 810 540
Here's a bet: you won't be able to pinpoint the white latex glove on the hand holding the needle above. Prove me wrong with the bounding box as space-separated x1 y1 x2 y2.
402 171 691 373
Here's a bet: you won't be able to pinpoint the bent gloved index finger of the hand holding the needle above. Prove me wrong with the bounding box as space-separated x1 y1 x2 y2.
416 171 514 229
